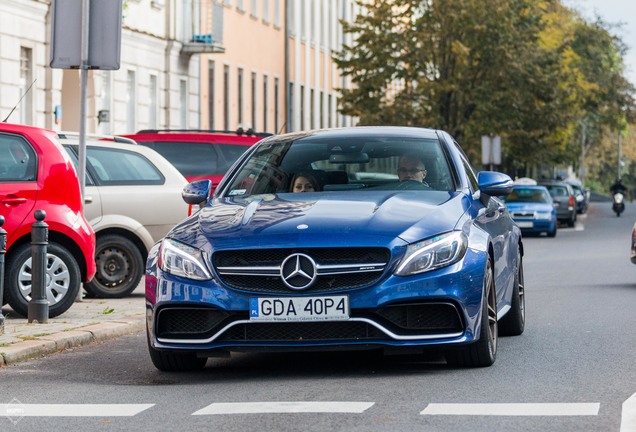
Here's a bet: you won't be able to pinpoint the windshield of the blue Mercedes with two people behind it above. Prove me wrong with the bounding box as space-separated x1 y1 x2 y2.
226 136 454 196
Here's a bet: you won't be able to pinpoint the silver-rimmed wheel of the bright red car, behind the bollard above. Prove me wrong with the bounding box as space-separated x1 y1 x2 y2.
5 243 82 318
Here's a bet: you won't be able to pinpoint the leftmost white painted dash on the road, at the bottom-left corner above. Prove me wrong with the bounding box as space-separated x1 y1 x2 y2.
0 403 155 417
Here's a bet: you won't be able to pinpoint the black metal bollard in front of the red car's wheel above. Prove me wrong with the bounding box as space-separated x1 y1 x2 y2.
28 210 49 323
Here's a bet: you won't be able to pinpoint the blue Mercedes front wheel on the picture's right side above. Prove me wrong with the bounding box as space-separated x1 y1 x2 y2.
446 257 499 367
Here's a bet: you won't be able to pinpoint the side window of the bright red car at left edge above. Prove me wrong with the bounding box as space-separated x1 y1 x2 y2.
0 134 37 182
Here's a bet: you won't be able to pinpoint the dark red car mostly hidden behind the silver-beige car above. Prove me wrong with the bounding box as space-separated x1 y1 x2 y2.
123 128 271 187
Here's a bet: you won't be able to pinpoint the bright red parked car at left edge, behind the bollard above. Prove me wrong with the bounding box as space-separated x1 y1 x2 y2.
0 123 95 317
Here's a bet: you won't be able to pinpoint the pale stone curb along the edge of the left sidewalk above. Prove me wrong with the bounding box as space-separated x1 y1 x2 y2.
0 317 146 367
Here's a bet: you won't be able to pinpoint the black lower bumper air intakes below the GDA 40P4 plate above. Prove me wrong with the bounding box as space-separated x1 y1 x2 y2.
157 303 463 343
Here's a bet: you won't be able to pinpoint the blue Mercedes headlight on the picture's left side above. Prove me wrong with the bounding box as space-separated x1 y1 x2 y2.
158 239 212 280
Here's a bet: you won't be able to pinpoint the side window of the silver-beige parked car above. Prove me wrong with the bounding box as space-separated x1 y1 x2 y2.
86 147 165 185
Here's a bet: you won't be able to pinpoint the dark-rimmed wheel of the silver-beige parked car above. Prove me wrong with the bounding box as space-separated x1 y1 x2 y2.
84 234 144 298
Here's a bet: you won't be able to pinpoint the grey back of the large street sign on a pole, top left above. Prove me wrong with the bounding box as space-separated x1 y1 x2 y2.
50 0 122 70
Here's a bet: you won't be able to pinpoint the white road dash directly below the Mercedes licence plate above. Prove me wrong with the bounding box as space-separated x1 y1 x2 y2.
192 402 375 415
